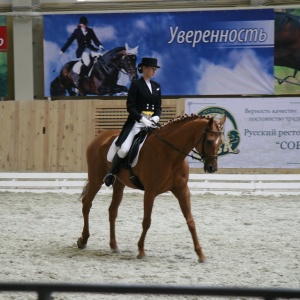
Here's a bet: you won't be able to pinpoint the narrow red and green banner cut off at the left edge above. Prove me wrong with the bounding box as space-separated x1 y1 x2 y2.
0 16 8 97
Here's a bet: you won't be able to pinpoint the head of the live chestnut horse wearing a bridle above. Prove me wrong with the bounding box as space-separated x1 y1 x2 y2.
196 115 226 173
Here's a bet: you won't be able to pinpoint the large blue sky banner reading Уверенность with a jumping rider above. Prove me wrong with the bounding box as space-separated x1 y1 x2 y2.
44 9 274 96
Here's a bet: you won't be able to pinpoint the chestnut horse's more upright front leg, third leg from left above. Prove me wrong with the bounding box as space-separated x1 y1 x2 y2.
137 192 155 258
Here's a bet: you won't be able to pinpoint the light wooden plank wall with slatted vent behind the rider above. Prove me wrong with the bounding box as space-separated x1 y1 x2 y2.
0 99 184 172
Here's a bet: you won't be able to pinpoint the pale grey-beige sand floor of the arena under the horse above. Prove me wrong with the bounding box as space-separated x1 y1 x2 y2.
0 192 300 300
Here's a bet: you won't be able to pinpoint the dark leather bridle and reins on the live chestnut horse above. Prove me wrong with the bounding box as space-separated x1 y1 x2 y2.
149 123 223 162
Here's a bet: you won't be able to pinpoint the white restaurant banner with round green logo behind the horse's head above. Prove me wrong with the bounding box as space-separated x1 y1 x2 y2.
185 98 300 168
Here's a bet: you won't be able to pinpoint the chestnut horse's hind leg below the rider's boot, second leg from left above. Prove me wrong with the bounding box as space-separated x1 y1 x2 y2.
108 179 125 253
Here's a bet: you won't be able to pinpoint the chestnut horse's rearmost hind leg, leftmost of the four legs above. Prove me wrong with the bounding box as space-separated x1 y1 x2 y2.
77 182 102 249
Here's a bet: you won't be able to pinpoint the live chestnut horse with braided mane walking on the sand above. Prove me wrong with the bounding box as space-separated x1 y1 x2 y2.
77 115 226 262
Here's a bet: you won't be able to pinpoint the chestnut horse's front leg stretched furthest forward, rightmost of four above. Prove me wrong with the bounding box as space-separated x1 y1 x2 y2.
172 185 205 262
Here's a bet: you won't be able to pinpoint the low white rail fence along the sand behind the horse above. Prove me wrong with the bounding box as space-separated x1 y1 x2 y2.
0 172 300 195
